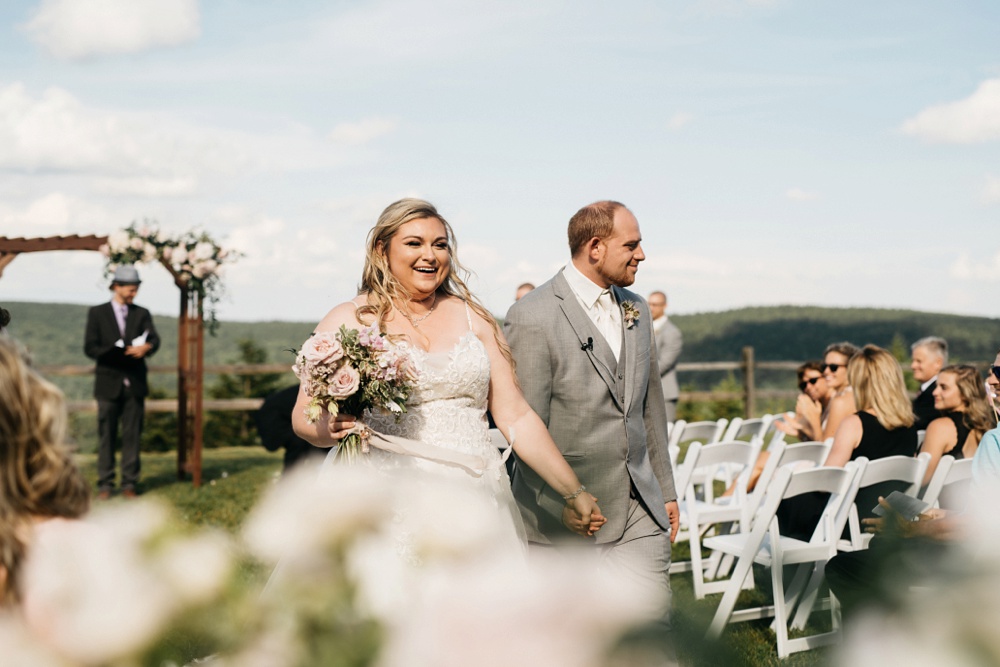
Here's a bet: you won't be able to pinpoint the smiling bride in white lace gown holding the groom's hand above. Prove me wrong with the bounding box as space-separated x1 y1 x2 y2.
292 199 606 542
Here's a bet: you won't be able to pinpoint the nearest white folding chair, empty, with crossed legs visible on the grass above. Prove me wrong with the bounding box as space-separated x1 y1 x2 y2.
705 462 857 658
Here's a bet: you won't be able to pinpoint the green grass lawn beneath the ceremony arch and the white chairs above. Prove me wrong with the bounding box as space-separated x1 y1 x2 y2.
78 447 828 667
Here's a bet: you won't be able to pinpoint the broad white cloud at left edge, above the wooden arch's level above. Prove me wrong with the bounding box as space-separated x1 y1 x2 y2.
0 83 248 197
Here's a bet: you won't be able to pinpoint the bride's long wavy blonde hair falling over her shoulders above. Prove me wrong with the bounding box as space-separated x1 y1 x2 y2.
358 198 514 366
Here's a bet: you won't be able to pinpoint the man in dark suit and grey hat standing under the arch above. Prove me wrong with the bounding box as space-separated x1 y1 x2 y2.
83 266 160 499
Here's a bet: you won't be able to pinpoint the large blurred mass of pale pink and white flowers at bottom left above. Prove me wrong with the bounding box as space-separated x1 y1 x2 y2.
0 466 656 667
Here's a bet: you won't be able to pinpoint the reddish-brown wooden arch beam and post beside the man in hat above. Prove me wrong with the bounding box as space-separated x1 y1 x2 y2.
0 235 205 487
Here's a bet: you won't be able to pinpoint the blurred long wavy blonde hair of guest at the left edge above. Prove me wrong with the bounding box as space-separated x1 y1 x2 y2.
0 337 90 606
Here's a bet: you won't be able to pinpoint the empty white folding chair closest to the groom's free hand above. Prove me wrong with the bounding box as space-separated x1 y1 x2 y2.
672 440 760 600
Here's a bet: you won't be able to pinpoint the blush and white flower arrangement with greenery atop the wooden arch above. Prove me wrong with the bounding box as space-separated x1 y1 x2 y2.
100 221 242 332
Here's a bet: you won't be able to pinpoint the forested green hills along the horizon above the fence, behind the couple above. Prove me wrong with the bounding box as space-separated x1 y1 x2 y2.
3 302 1000 364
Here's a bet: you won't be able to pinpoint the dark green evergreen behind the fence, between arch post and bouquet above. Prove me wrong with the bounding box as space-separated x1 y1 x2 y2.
204 338 289 447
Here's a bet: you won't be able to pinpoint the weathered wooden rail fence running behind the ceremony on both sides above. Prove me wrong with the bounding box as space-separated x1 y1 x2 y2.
38 347 801 417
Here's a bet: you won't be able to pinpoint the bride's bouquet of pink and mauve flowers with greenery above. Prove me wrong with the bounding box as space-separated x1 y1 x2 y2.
292 326 417 459
